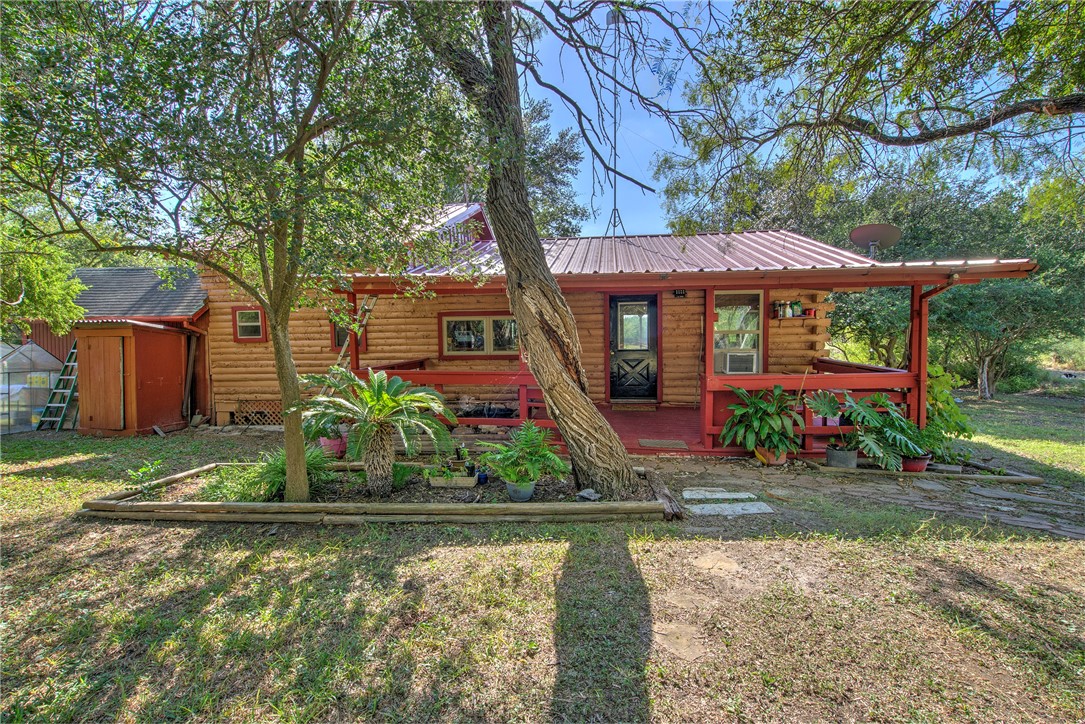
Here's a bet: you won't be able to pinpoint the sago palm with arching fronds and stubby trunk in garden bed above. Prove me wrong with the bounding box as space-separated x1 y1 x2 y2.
302 367 456 495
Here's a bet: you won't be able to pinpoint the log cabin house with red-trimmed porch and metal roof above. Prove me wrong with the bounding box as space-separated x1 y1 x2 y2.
201 204 1036 455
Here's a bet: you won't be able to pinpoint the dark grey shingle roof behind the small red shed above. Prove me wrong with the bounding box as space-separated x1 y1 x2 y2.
75 267 207 317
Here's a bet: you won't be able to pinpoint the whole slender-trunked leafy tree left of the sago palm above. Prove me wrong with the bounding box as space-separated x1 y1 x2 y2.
0 0 472 499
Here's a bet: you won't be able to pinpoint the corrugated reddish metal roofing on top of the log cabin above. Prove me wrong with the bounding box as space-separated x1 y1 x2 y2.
410 230 880 276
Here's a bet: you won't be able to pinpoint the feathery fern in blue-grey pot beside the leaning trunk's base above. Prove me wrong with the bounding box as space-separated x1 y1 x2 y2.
480 420 569 503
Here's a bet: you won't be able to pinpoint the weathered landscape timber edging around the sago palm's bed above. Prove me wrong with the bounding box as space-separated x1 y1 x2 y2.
76 462 665 525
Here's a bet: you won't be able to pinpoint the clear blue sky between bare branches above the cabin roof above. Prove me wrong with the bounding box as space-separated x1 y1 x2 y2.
524 12 703 236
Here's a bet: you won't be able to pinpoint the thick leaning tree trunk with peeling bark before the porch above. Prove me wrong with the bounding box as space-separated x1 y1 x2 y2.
480 3 635 497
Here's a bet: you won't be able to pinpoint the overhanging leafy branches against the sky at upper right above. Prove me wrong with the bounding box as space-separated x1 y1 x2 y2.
658 0 1085 223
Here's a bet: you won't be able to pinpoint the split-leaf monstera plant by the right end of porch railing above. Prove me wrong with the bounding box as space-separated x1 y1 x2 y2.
806 391 926 470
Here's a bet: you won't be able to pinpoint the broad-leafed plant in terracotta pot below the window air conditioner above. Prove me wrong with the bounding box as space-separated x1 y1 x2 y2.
719 384 804 466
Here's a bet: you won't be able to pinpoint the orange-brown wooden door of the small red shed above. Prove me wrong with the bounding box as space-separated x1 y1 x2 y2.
79 336 125 430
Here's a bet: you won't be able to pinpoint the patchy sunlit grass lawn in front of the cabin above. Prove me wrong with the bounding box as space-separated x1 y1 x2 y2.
0 396 1085 722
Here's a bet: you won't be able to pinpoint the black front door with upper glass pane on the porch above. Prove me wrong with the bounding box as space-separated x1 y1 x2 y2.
610 294 660 401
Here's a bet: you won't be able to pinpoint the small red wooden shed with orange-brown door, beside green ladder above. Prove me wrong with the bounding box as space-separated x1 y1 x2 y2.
75 319 194 435
